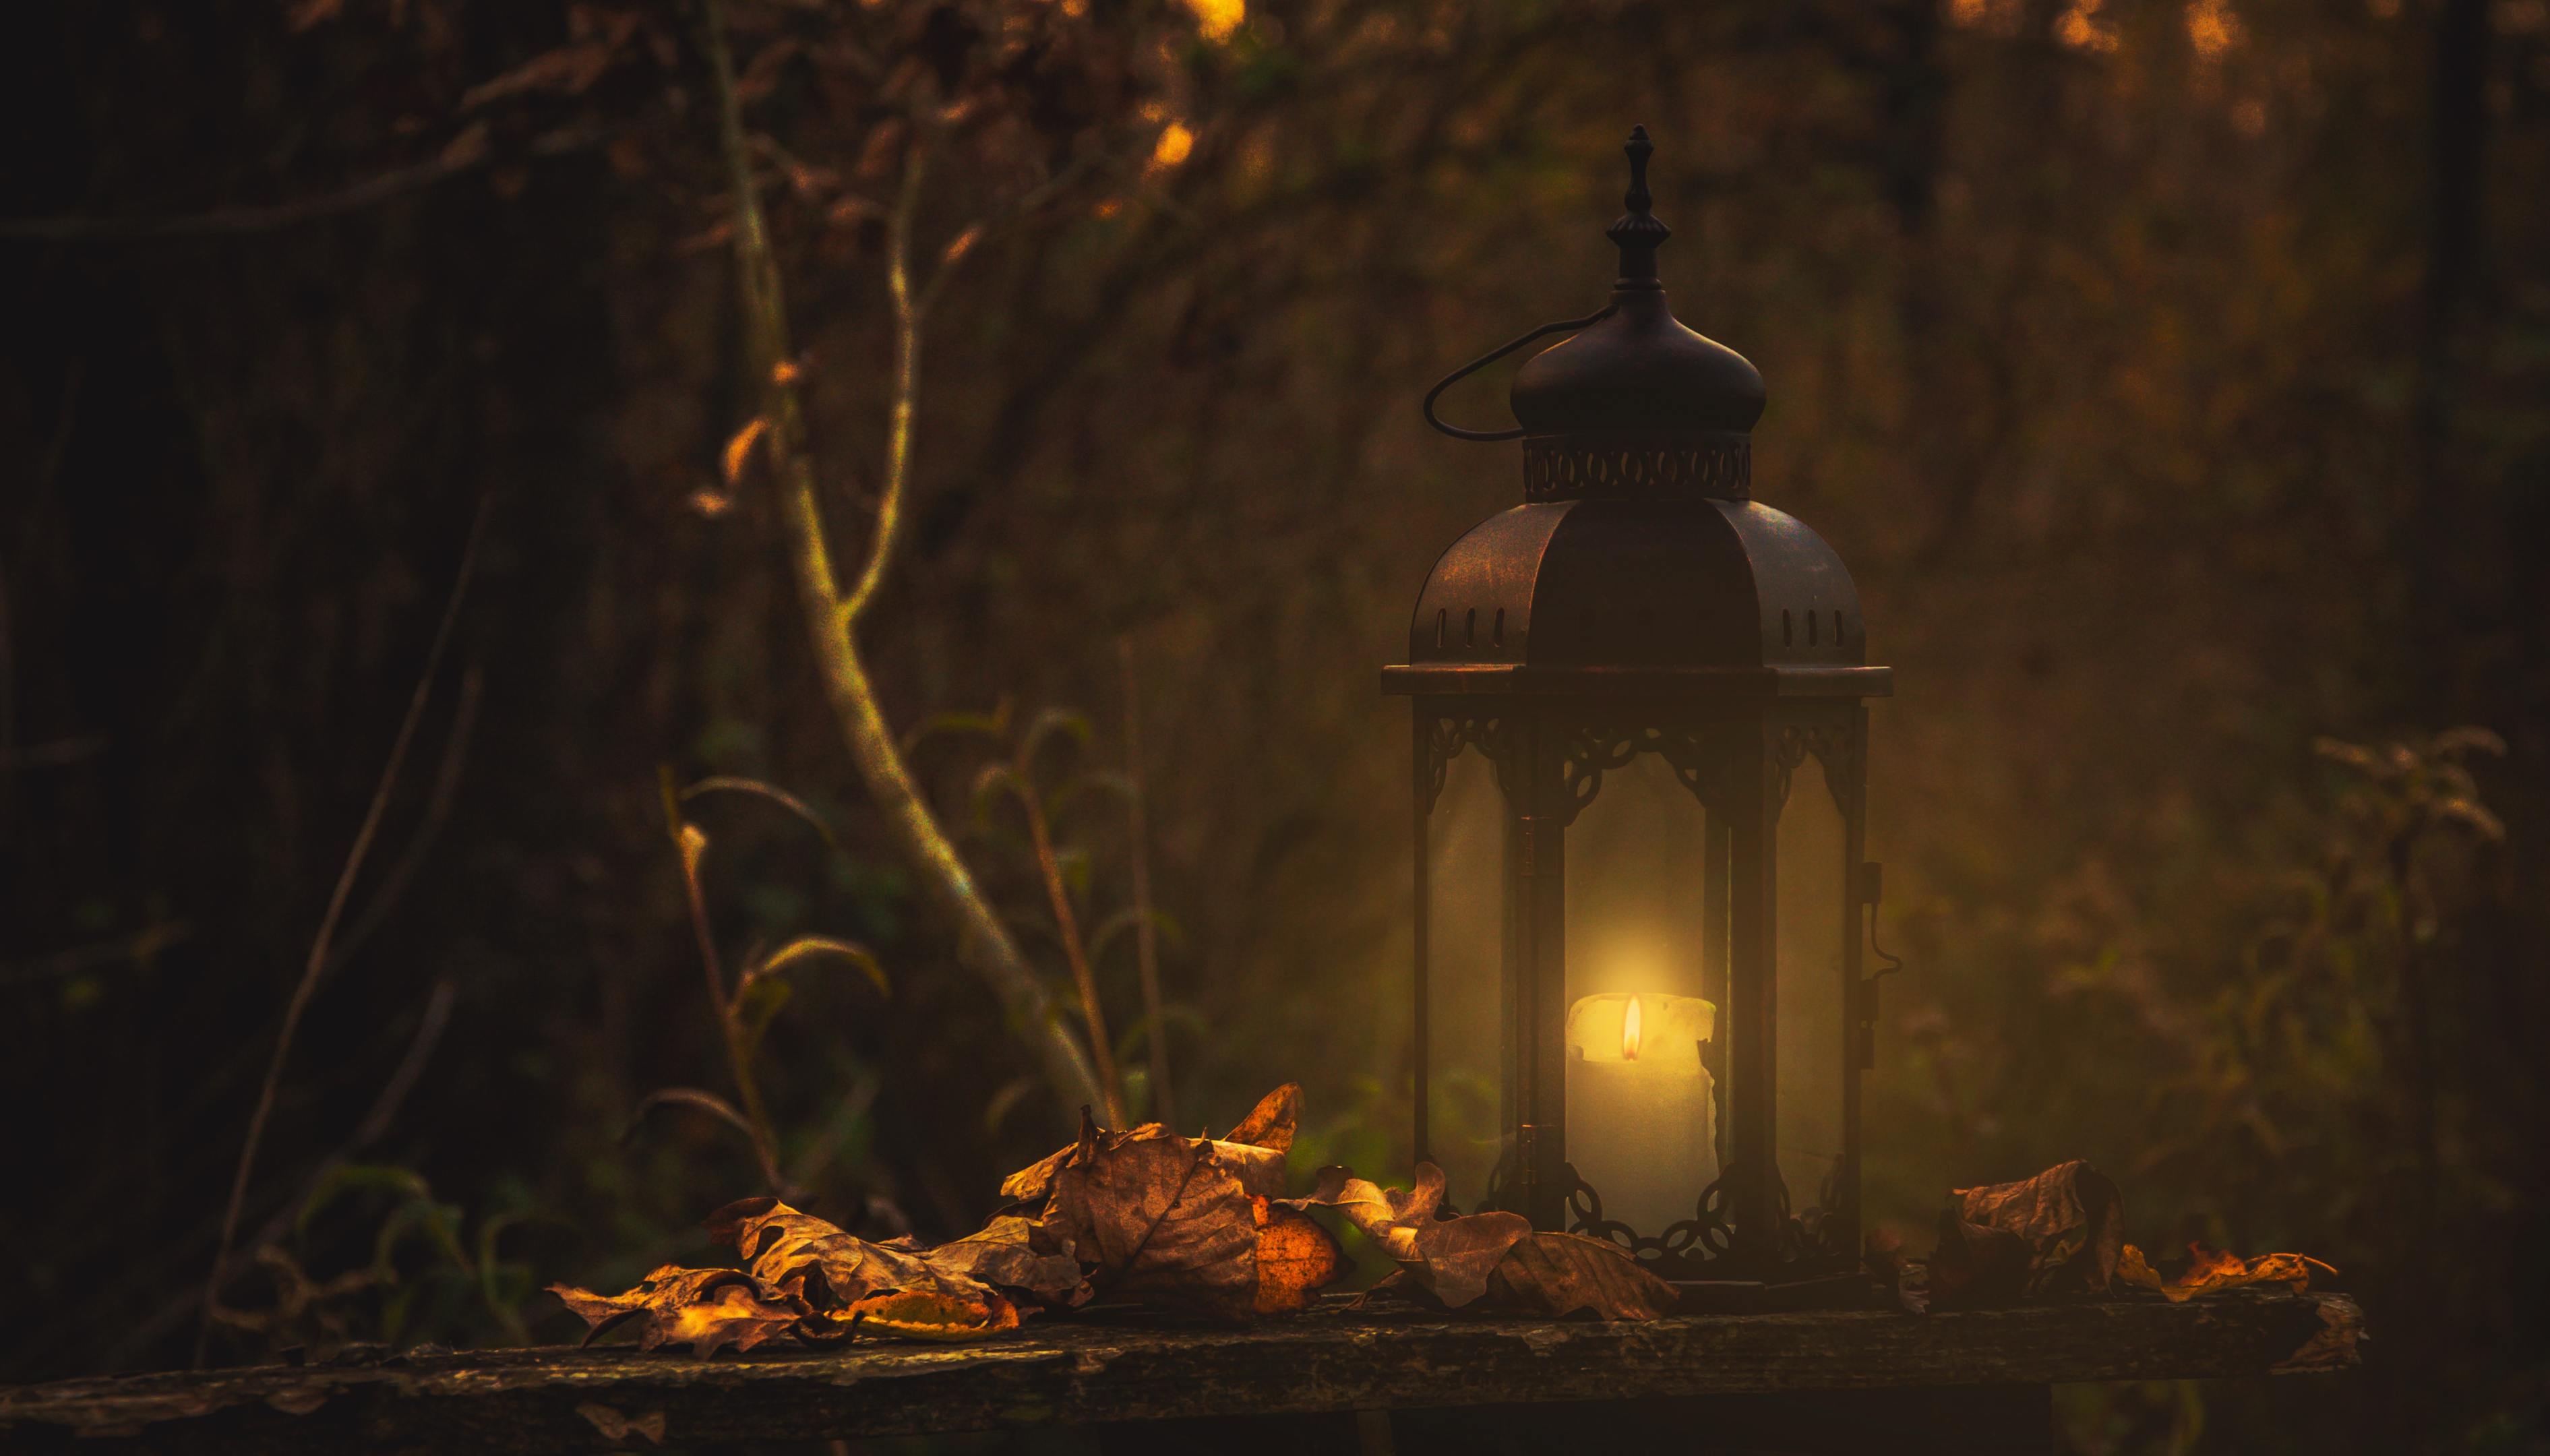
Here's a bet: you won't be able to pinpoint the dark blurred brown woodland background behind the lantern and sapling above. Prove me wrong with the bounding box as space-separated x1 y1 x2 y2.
0 0 2550 1453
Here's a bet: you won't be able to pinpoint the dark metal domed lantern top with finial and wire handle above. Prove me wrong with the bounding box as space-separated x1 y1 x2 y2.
1385 127 1892 696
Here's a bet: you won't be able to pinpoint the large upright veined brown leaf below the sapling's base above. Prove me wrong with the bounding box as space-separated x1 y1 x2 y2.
1043 1112 1257 1318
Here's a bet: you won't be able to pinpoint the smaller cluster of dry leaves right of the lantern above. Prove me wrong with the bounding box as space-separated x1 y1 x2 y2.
1866 1160 2336 1313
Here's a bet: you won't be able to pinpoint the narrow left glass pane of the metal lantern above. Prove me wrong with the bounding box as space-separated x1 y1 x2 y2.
1423 752 1515 1209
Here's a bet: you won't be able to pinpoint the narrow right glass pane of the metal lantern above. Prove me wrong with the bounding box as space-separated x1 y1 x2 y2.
1772 758 1851 1219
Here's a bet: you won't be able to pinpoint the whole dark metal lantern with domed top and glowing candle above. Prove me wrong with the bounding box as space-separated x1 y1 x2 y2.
1382 127 1892 1306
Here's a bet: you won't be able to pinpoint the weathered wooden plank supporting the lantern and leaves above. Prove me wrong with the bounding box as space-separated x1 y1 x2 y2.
0 1293 2364 1453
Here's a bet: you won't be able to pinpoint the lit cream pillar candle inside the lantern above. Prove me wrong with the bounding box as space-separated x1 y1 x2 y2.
1569 992 1719 1237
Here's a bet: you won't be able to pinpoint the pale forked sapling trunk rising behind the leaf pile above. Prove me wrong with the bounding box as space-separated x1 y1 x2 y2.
704 0 1104 1101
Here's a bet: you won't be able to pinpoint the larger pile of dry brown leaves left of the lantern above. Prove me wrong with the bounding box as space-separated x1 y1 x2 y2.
551 1086 1675 1356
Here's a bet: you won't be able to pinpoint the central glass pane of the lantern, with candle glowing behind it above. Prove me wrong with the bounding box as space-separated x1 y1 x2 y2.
1566 752 1724 1237
